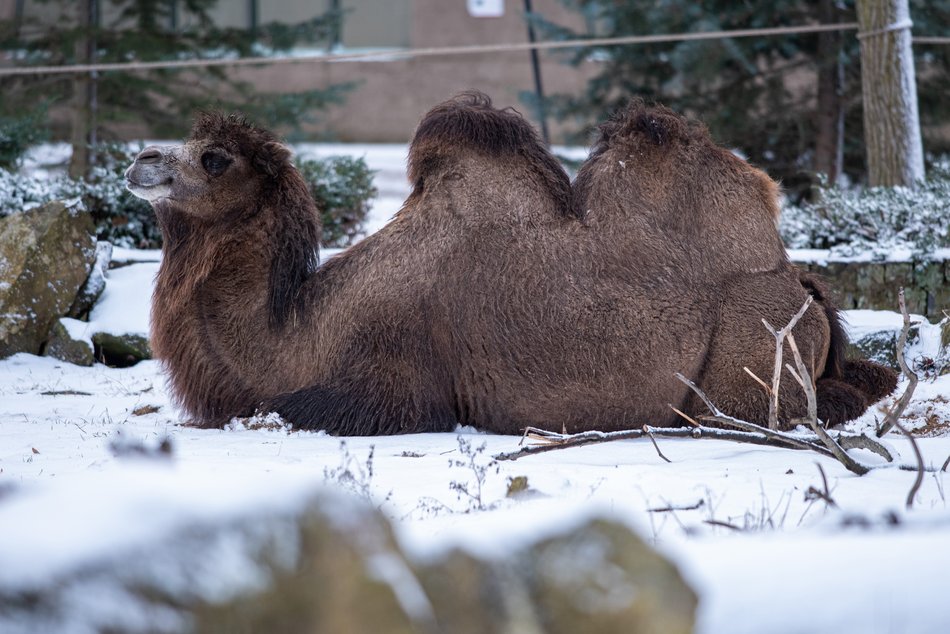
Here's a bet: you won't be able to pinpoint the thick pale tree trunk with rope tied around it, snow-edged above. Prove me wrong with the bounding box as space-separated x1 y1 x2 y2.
857 0 924 187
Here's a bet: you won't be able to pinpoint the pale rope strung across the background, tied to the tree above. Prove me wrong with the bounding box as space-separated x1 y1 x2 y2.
0 21 950 77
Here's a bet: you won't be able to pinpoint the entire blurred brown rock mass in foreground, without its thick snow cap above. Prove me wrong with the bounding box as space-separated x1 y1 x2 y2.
0 478 697 634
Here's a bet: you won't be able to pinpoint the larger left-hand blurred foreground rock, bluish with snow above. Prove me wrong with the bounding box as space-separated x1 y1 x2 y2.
0 485 425 634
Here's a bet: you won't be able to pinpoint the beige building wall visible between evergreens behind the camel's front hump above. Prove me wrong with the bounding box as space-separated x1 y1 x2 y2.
236 0 594 142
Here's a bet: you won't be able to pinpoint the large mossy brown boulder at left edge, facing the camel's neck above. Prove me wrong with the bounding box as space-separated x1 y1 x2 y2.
0 201 95 358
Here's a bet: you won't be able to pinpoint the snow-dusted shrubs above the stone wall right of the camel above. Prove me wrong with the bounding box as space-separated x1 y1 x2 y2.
779 157 950 259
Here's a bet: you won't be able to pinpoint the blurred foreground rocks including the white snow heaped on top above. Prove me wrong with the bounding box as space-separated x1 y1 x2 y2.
0 459 696 634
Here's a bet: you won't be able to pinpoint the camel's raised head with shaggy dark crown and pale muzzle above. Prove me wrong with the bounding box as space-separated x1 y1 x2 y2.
125 113 293 221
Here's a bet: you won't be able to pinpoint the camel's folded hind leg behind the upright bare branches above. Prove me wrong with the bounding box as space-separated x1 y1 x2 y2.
689 270 844 429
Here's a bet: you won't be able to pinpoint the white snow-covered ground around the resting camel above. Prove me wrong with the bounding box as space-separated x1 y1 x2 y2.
0 145 950 634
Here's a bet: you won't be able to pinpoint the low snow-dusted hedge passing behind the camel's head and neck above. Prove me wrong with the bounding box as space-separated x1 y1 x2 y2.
0 144 376 248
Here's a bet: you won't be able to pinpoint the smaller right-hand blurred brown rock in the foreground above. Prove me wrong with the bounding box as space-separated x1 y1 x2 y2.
416 519 697 634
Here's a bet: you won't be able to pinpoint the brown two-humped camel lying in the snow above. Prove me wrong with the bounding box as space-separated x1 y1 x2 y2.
126 93 900 435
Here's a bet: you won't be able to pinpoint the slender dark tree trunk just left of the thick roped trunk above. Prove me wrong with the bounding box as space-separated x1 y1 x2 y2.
814 0 844 185
